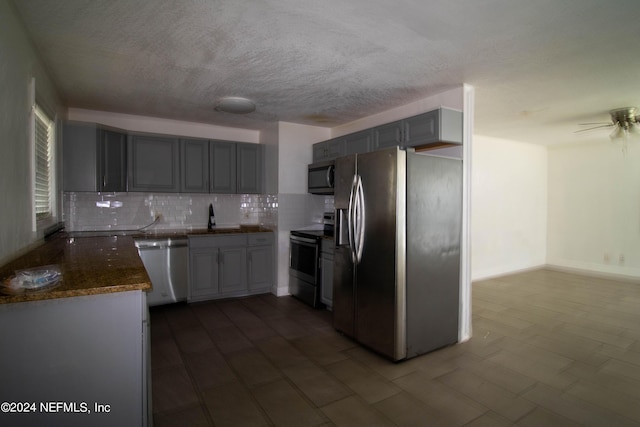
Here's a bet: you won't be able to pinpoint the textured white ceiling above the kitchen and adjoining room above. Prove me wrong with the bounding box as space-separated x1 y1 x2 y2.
13 0 640 144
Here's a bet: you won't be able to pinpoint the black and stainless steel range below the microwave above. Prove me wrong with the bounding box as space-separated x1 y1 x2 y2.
289 212 334 308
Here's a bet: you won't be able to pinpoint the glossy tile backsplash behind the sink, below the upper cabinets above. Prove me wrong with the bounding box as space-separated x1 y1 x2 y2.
63 192 278 231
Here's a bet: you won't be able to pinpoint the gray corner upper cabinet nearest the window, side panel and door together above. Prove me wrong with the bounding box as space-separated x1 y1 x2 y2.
62 122 127 192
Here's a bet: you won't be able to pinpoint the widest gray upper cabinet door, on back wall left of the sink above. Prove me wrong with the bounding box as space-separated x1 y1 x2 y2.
129 135 180 192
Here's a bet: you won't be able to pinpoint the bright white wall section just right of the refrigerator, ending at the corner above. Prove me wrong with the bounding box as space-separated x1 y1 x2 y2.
471 135 547 280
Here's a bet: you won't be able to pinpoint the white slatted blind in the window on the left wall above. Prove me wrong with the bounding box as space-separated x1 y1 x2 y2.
34 105 53 220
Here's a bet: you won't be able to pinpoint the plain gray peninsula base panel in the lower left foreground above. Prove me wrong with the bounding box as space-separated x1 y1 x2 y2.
0 291 151 427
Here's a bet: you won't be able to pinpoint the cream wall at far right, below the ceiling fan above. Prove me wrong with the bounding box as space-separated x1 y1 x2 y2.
547 139 640 279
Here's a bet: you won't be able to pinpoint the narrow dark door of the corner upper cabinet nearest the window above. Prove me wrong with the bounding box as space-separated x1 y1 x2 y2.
98 130 127 191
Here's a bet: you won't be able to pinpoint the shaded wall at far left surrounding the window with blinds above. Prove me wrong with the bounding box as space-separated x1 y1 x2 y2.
0 0 64 263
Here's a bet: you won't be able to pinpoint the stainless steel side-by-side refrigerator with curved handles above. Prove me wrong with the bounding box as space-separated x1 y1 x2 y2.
333 148 462 361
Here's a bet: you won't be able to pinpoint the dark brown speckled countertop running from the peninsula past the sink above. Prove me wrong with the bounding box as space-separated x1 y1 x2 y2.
0 225 272 304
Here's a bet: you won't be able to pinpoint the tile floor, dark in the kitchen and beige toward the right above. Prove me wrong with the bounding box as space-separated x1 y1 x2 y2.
151 270 640 427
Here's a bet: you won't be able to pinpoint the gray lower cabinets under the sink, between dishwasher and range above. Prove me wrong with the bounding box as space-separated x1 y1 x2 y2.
187 233 275 302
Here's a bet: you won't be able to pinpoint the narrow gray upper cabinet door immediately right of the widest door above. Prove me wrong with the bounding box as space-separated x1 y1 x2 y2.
180 139 209 193
